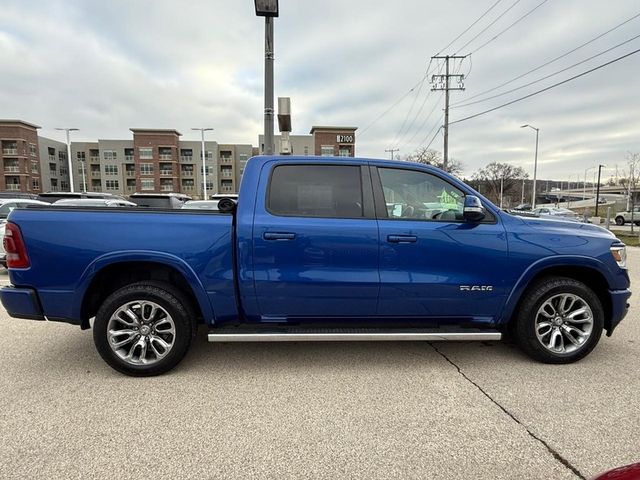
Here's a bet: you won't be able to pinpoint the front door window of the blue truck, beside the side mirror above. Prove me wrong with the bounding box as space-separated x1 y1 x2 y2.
378 168 464 221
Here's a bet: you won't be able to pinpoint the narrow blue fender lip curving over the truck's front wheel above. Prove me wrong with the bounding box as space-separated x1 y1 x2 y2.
497 255 614 324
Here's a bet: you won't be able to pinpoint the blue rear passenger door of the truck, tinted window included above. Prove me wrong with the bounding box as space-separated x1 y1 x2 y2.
253 163 379 321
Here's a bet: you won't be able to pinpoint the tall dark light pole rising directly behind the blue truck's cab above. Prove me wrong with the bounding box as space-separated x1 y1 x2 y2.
254 0 278 155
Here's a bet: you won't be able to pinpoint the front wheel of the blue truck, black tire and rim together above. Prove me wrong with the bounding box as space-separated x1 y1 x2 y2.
514 277 604 363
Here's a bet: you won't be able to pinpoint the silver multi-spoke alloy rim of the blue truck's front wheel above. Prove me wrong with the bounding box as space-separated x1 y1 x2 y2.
536 293 593 354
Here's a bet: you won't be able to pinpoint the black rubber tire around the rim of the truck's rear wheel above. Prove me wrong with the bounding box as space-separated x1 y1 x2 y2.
93 281 197 377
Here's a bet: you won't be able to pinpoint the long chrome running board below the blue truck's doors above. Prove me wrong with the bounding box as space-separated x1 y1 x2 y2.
208 328 502 342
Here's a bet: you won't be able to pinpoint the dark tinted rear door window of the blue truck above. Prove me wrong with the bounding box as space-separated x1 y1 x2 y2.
268 165 363 218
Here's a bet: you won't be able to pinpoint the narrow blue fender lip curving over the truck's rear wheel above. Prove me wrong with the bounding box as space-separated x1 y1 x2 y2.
72 250 215 323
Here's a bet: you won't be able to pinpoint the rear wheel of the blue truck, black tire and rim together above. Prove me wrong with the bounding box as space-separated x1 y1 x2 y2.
93 282 196 377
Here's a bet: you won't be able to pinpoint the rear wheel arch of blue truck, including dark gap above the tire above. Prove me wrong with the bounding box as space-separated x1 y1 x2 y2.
73 252 214 329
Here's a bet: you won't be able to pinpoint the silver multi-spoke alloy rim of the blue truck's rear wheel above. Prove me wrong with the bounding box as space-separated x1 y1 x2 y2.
107 300 176 365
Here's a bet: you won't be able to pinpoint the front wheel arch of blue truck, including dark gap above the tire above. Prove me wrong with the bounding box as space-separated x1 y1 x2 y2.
500 257 613 332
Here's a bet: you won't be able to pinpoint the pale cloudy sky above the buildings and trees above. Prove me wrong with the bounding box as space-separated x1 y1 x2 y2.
0 0 640 181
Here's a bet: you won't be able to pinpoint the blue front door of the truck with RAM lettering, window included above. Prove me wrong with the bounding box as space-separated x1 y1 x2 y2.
372 167 507 324
